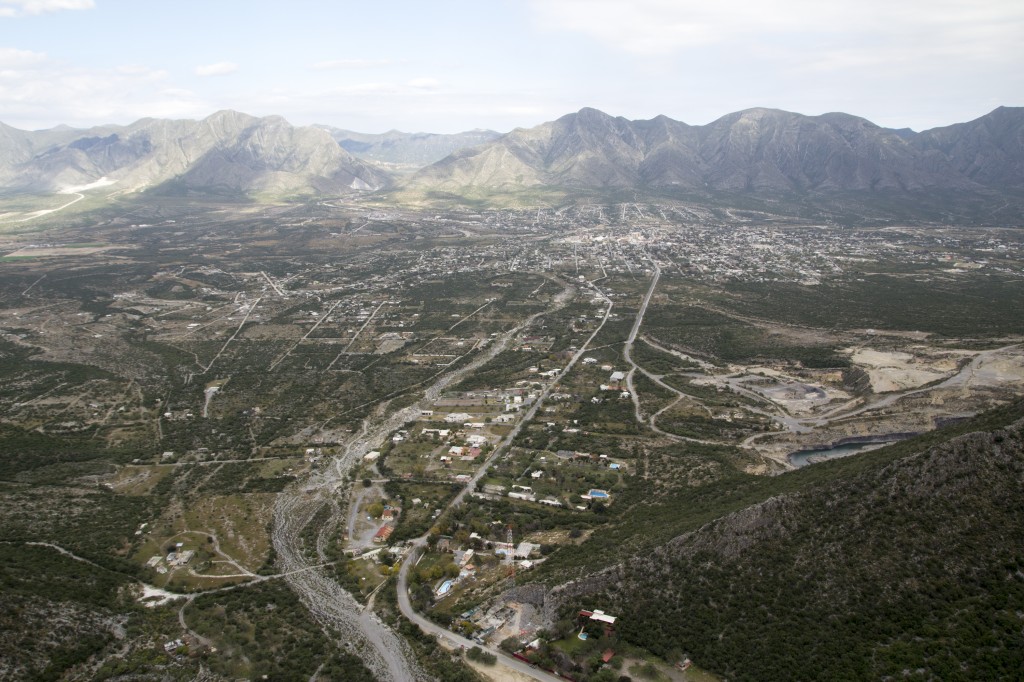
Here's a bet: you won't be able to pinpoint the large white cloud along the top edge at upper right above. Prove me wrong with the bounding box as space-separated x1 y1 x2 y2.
530 0 1024 59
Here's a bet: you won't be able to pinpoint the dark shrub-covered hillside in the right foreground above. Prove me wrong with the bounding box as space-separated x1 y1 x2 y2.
553 404 1024 680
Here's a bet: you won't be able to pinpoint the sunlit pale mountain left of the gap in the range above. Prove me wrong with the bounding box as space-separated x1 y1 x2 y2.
0 111 389 194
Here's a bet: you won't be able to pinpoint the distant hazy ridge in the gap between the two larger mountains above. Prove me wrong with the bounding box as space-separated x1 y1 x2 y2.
315 126 501 170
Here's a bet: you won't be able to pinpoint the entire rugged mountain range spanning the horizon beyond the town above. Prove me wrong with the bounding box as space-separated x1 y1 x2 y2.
0 106 1024 217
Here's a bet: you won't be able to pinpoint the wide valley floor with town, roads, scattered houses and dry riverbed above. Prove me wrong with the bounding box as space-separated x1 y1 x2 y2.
0 197 1024 680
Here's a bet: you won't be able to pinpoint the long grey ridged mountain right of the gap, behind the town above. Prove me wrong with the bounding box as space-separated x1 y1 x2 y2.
411 108 1024 193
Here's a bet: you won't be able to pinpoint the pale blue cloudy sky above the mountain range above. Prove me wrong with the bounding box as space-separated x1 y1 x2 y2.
0 0 1024 133
